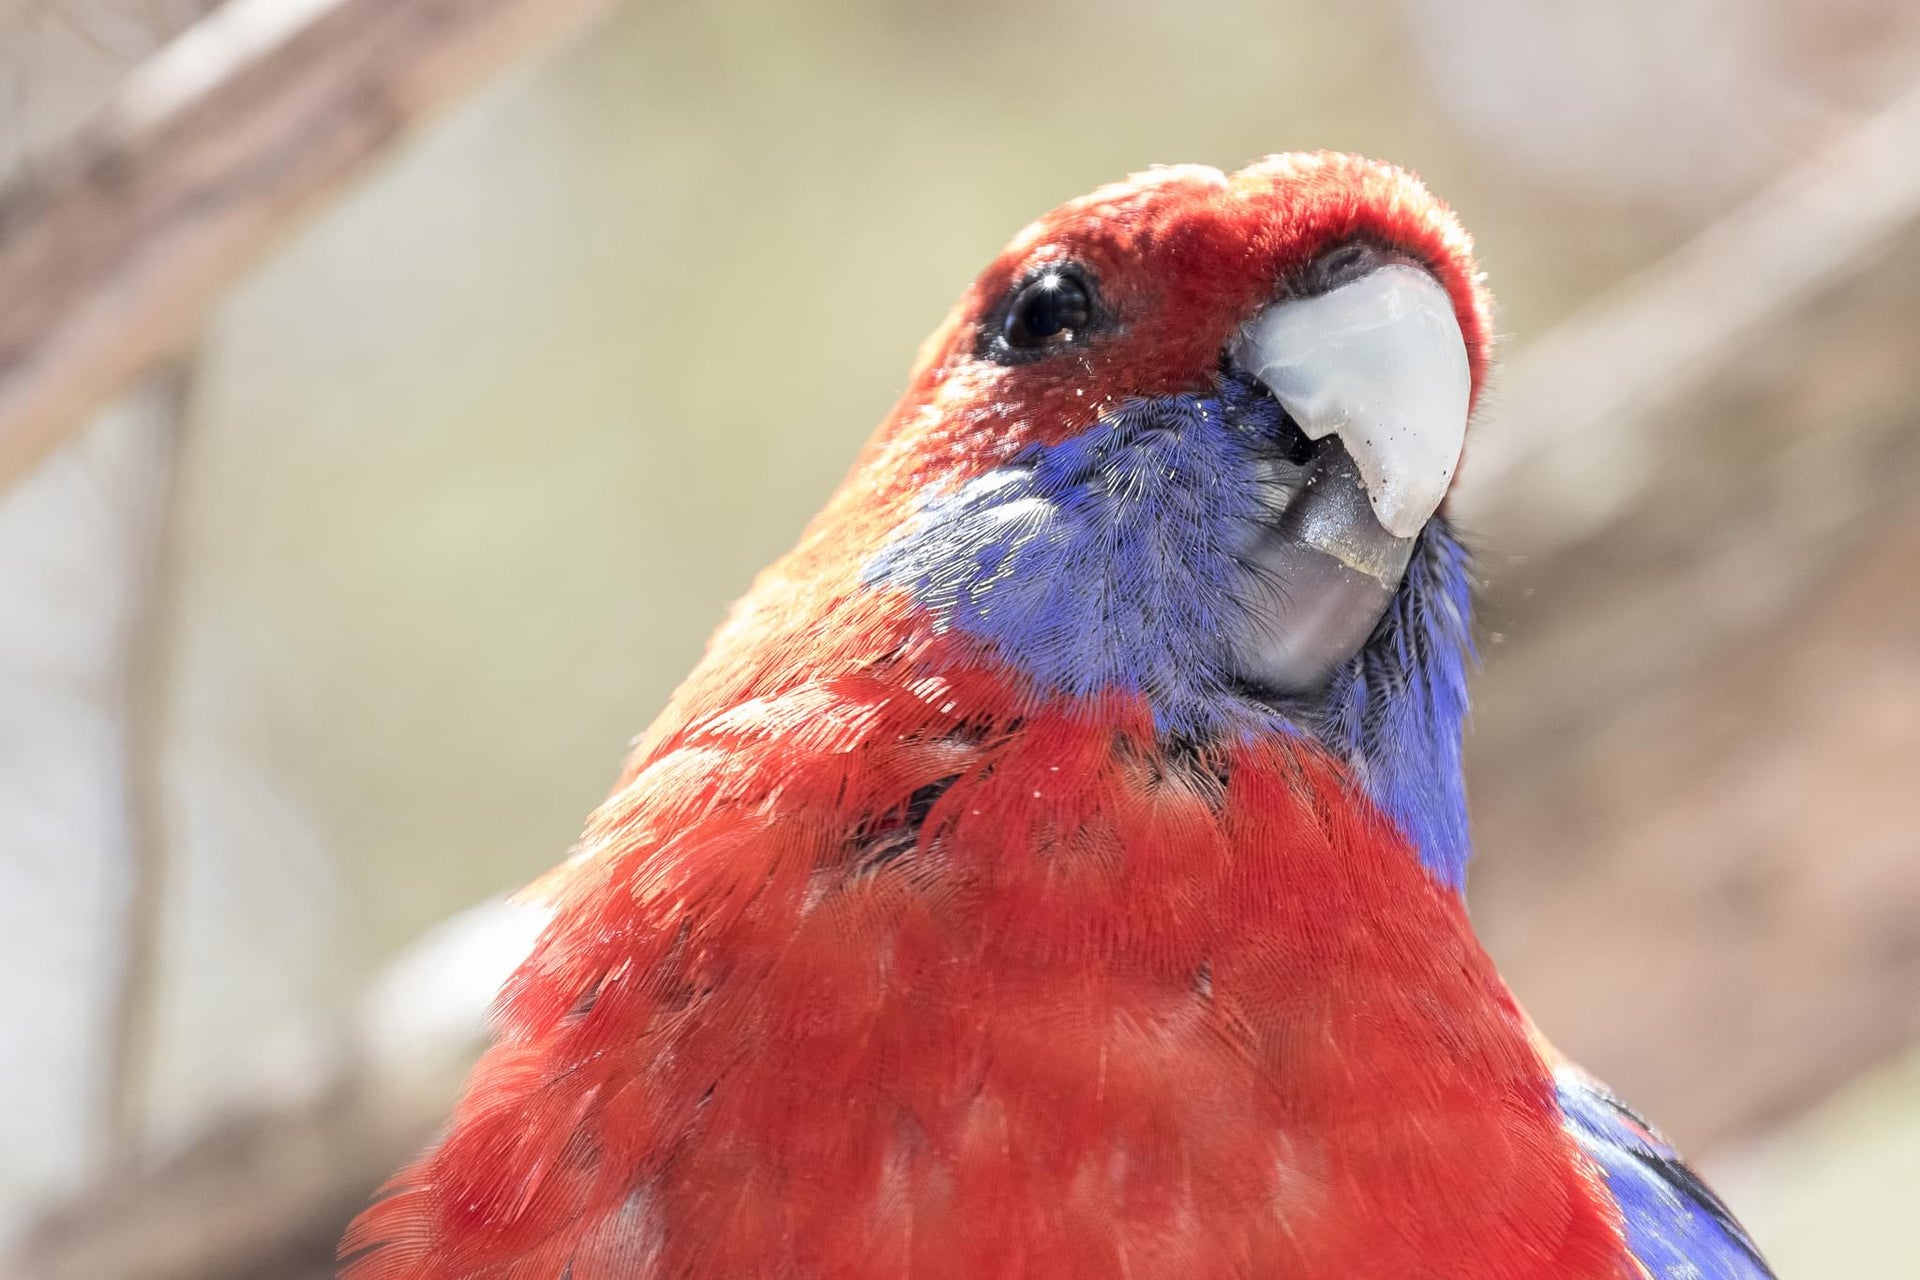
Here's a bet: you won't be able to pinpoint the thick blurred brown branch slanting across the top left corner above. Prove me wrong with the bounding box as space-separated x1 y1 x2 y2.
0 0 612 486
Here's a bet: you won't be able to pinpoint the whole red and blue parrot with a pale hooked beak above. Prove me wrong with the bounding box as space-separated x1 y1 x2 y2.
340 152 1772 1280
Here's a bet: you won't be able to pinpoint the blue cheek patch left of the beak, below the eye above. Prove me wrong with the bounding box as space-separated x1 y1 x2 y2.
866 395 1260 735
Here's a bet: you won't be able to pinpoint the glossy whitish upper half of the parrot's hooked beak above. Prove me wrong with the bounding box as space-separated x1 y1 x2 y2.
1233 263 1473 537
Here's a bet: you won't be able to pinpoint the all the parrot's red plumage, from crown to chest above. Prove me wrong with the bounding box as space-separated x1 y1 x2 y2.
344 155 1638 1280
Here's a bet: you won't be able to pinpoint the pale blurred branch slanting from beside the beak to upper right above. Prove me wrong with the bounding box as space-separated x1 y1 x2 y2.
1455 83 1920 557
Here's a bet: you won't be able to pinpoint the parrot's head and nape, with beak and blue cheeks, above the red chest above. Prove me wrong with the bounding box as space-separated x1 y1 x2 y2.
668 154 1488 879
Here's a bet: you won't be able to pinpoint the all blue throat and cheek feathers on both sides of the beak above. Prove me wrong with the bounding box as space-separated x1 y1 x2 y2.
864 376 1471 889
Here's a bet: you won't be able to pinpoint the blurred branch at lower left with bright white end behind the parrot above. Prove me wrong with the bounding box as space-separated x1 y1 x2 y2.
0 902 545 1280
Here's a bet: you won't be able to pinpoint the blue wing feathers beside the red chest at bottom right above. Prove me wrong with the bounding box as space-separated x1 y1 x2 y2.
1555 1067 1776 1280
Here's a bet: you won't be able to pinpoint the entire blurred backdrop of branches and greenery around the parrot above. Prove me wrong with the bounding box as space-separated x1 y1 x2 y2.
0 0 1920 1280
